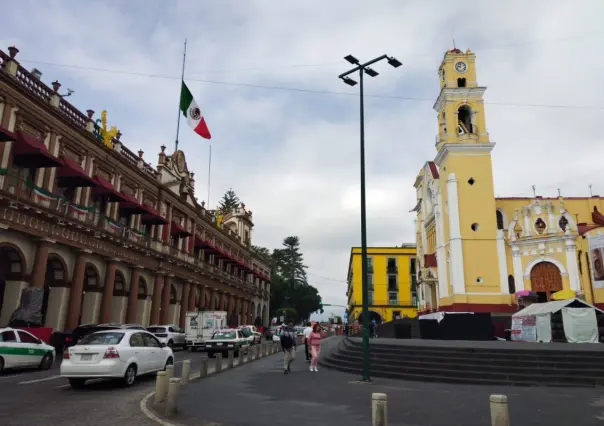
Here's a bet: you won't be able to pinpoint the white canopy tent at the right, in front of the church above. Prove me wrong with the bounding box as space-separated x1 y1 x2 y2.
512 298 604 343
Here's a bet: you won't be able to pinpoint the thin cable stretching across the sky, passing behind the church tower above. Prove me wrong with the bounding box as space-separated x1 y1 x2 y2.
16 60 604 111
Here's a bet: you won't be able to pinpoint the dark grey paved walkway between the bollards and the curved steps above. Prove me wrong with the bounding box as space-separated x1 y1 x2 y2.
165 336 604 426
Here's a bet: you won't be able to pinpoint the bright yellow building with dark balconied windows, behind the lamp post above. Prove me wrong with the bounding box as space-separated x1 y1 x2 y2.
346 244 417 323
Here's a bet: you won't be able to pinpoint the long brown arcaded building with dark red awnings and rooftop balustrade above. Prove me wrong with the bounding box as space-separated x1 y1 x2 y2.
0 47 270 330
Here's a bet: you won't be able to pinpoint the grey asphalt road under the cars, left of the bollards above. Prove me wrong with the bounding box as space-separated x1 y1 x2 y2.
0 350 226 426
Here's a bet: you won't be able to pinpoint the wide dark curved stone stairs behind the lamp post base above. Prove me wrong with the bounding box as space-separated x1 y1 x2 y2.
320 338 604 387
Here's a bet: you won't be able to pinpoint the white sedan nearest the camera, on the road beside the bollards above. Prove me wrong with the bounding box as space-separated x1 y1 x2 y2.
61 330 174 389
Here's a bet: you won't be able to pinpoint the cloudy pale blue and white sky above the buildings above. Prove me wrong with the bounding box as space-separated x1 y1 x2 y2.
0 0 604 316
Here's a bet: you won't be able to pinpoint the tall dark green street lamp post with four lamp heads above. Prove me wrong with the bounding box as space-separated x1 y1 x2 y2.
338 55 403 382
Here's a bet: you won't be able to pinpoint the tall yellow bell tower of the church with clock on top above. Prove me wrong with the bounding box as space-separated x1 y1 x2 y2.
434 49 503 303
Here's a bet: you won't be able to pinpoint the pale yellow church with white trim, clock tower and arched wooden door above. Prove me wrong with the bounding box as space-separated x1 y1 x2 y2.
413 49 604 313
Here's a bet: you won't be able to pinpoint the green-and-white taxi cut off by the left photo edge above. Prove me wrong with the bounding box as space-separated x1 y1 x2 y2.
0 327 55 374
